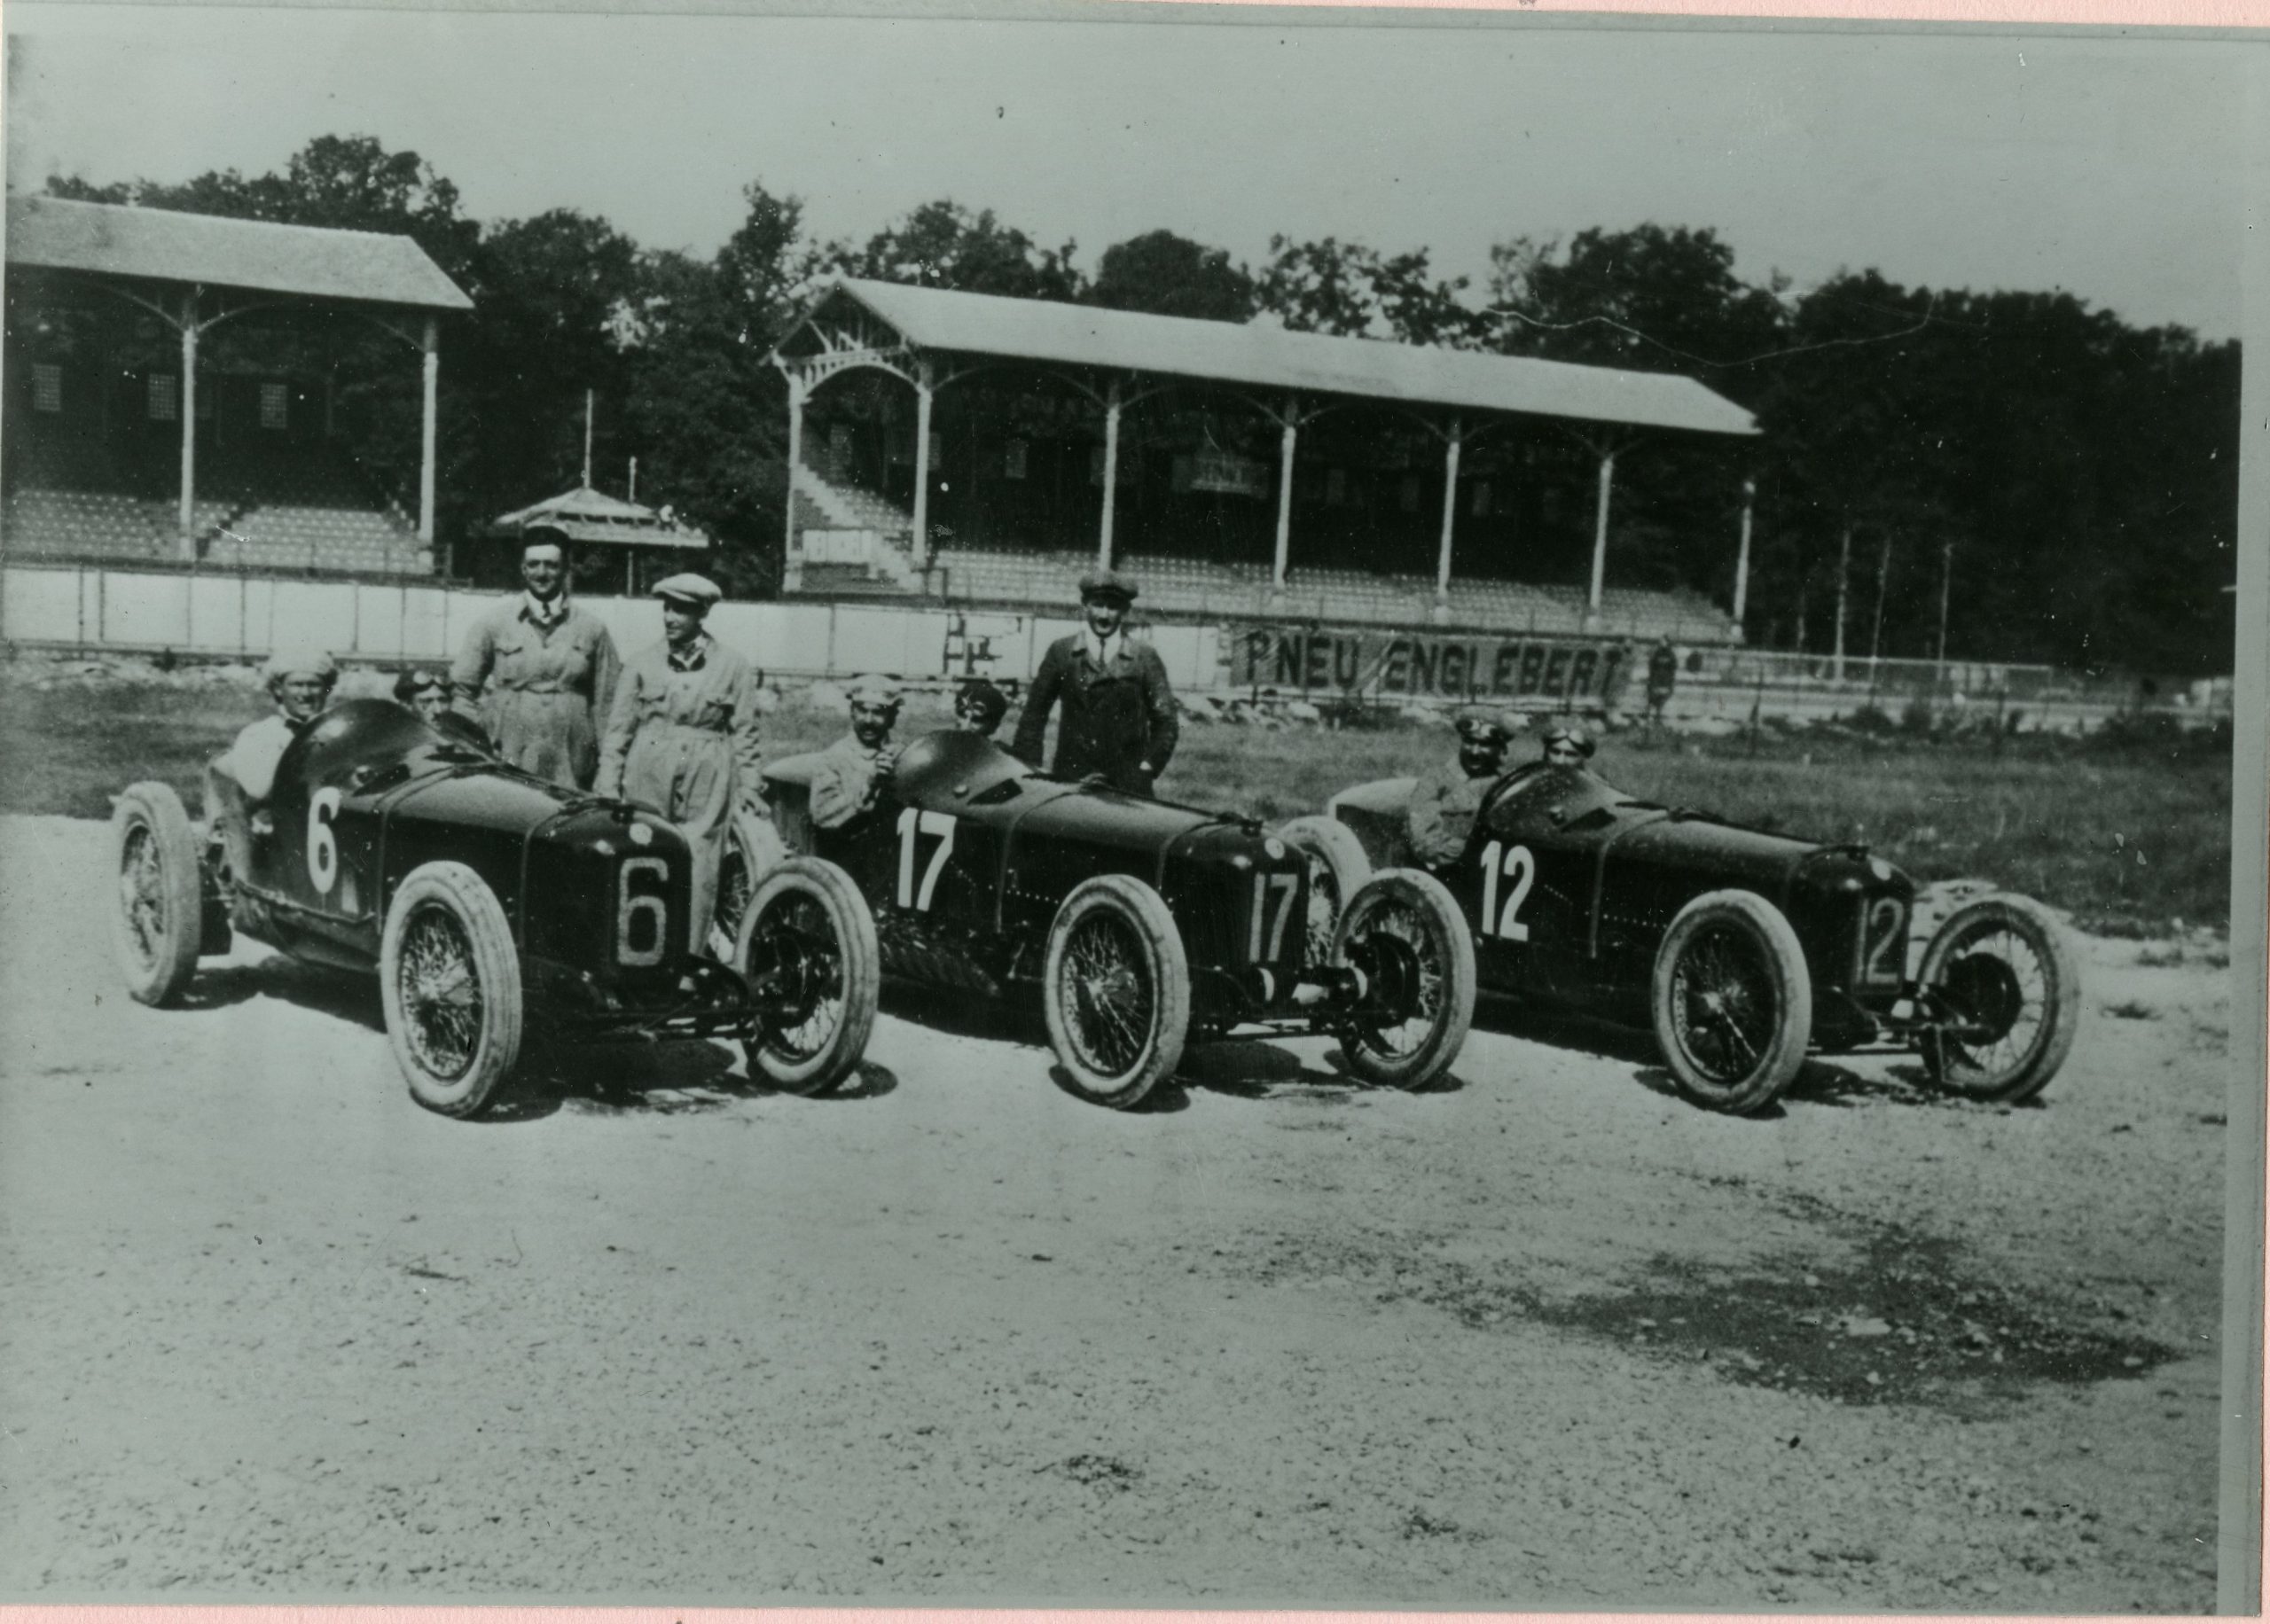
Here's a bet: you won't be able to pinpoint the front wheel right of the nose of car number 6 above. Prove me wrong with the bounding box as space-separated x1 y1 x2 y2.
733 857 883 1093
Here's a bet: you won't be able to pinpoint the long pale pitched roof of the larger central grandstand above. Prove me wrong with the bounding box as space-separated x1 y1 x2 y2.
783 277 1757 435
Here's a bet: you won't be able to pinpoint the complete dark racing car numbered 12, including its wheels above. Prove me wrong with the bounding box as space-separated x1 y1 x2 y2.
1316 762 2079 1112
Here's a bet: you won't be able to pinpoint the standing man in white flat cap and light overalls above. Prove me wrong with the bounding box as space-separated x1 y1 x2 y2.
592 574 761 950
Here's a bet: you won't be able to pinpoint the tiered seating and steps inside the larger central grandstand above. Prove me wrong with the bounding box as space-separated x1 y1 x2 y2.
794 470 1739 642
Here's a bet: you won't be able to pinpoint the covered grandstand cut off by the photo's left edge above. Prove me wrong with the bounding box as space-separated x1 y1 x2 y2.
0 198 470 578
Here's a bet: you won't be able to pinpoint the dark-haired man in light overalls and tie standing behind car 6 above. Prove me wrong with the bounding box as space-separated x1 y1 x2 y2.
450 531 622 789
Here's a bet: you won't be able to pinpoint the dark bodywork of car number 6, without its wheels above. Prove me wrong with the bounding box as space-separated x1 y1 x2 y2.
207 699 755 1039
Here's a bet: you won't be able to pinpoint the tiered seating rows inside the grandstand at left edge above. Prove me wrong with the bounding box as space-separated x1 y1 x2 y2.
0 442 434 576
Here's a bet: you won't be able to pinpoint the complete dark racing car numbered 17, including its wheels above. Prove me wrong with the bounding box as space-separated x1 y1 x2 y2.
749 730 1473 1107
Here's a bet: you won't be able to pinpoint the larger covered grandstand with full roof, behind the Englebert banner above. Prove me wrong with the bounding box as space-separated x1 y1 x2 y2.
774 279 1755 642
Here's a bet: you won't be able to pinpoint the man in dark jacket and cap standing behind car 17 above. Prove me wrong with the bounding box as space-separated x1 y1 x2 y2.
1010 569 1180 796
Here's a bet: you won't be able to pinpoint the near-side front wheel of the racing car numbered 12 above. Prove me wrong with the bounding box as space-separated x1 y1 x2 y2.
1650 892 1813 1112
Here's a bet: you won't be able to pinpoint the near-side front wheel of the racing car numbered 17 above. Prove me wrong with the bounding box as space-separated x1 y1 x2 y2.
1039 873 1189 1109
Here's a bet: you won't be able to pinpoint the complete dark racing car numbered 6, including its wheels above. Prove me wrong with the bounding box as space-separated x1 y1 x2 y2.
111 699 879 1116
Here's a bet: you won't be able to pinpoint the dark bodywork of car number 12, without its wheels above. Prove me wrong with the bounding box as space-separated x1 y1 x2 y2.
1328 762 1916 1050
